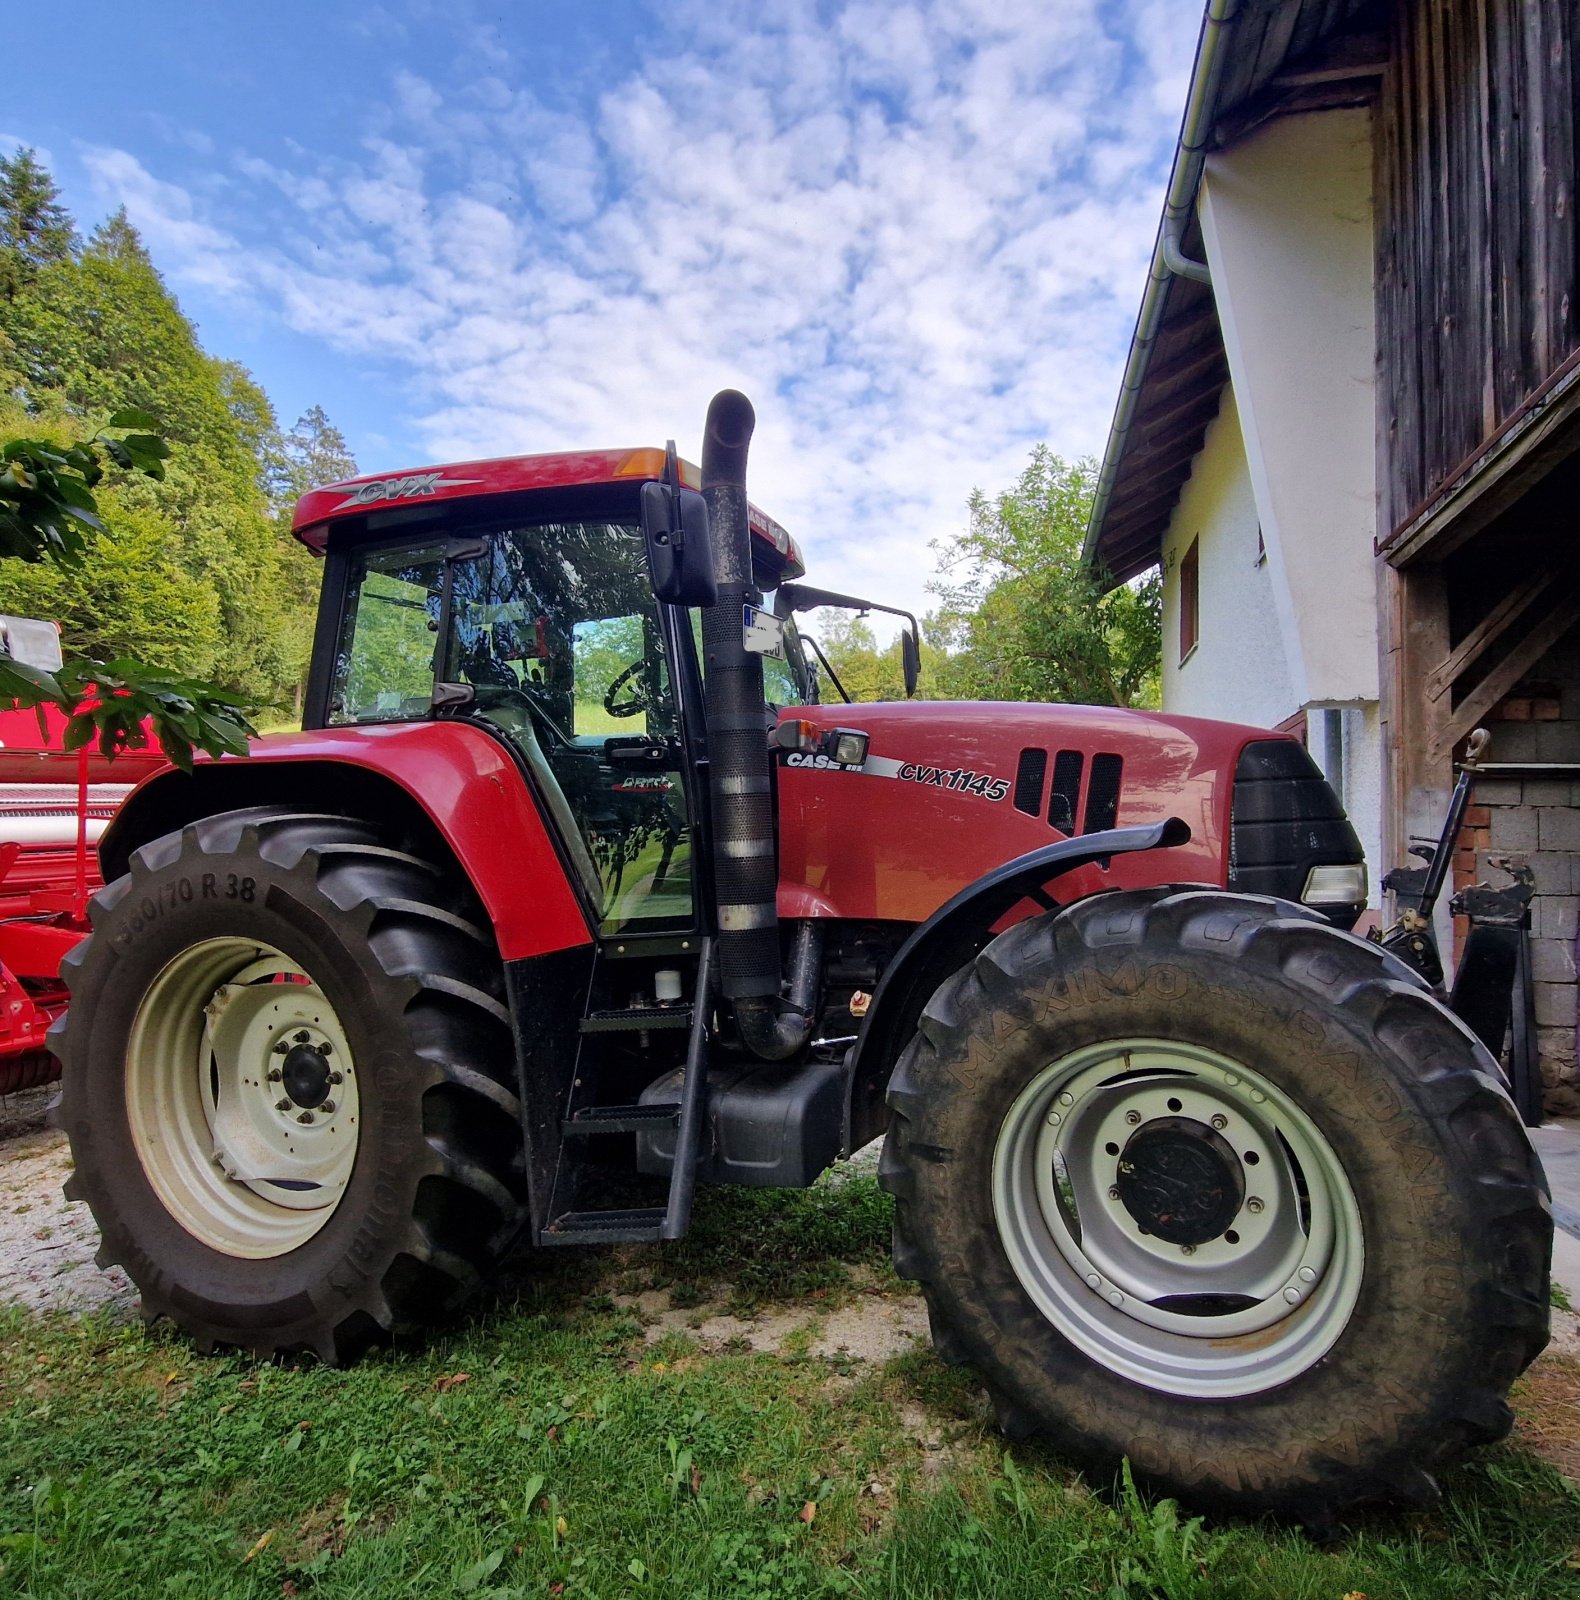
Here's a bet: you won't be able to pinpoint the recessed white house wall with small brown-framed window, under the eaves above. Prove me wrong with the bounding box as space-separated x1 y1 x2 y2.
1163 389 1300 728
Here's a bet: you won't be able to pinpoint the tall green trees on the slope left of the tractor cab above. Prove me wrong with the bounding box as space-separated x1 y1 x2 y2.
0 150 355 726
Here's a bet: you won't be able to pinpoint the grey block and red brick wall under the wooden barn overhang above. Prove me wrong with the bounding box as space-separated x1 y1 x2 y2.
1454 668 1580 1115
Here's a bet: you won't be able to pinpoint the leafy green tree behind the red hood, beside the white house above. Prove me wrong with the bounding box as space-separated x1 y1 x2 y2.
929 445 1163 706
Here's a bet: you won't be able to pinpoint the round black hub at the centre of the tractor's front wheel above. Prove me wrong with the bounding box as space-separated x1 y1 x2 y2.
1115 1117 1246 1245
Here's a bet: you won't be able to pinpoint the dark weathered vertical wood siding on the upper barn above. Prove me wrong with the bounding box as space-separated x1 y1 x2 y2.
1377 0 1580 538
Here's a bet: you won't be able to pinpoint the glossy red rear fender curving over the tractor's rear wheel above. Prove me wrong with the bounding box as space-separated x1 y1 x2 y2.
99 722 592 962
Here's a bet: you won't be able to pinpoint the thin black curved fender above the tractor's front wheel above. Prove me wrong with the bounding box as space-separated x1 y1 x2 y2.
849 816 1191 1150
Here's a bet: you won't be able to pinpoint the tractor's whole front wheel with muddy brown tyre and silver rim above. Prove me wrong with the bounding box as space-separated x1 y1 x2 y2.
883 891 1551 1523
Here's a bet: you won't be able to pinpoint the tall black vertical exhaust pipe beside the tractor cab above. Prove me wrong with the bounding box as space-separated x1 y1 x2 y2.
702 389 822 1061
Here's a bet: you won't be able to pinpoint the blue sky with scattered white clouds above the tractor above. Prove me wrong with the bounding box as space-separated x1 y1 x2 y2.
9 0 1199 610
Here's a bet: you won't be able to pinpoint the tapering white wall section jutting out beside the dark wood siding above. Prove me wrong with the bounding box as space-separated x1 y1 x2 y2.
1201 109 1379 706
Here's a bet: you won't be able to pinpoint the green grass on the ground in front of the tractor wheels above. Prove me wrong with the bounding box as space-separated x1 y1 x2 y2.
0 1179 1580 1600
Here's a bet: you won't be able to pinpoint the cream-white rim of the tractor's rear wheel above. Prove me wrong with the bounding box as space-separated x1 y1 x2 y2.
126 938 360 1259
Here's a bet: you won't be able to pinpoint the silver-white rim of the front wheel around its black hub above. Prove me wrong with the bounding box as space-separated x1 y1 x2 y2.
993 1038 1364 1398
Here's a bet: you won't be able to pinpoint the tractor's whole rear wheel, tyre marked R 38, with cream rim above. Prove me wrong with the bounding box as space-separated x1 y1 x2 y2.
53 808 525 1362
